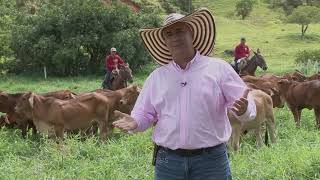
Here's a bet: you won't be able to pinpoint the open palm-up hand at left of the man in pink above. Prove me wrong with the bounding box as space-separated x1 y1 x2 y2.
112 110 138 132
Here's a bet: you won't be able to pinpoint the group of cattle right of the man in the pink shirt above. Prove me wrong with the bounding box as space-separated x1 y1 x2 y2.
228 70 320 150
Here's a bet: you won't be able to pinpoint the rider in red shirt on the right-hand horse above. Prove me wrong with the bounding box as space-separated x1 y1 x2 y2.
234 37 250 74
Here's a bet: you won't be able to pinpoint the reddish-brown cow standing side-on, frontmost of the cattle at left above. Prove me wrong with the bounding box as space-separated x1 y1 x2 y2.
16 92 112 140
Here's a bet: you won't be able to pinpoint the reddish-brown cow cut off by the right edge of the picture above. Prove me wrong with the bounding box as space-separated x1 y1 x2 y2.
278 80 320 128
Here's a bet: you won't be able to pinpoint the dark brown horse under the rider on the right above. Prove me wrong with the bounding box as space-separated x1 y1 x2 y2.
232 49 268 76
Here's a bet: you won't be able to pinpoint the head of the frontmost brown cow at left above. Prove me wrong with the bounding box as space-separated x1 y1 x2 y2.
15 92 36 119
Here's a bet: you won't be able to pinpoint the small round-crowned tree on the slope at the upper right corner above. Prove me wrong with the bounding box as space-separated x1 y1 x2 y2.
288 6 320 37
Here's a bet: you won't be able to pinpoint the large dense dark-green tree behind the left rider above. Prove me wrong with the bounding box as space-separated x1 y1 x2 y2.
11 0 160 76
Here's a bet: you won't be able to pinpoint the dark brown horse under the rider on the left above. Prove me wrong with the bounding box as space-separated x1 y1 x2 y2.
102 64 132 91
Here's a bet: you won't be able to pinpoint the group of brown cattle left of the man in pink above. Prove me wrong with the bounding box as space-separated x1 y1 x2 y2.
0 86 140 140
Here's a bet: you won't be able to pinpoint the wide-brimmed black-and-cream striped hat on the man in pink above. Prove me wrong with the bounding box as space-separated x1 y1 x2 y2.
140 8 216 65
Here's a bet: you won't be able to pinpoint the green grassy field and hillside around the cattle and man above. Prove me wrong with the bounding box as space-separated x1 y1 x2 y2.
0 0 320 180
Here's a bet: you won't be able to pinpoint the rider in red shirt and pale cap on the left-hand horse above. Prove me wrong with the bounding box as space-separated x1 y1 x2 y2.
102 47 124 89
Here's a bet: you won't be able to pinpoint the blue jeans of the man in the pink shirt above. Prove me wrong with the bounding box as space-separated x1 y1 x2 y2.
155 144 232 180
